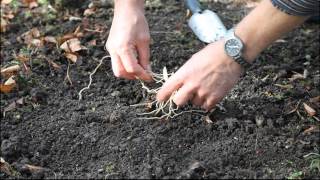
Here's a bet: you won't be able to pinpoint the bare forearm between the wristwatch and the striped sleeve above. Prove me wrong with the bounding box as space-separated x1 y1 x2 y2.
235 0 307 62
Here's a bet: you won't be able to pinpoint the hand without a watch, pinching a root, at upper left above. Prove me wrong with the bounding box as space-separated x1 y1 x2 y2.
106 1 152 81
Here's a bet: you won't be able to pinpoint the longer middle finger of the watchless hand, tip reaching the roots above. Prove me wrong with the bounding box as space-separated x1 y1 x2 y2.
120 49 152 81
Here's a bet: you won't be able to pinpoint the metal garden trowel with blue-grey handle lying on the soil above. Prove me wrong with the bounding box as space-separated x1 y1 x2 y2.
186 0 227 43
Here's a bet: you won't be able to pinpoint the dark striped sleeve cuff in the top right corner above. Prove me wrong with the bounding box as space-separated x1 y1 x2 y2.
271 0 320 16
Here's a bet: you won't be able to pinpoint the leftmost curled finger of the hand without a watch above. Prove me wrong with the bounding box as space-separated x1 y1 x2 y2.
110 53 135 79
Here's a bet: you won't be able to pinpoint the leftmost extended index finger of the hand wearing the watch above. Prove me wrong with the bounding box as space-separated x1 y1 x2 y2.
157 73 183 102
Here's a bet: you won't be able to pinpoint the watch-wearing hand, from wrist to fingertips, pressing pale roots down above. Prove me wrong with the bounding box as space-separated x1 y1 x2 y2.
157 40 242 110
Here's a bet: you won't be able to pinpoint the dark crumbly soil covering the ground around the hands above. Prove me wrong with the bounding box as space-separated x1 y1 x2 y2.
0 1 320 178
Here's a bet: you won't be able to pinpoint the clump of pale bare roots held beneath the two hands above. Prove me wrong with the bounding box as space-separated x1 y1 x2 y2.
131 67 205 120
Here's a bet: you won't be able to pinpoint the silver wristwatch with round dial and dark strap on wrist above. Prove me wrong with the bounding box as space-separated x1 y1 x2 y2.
224 28 251 69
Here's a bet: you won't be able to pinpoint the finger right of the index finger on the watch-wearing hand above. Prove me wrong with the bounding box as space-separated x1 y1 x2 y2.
173 85 194 106
